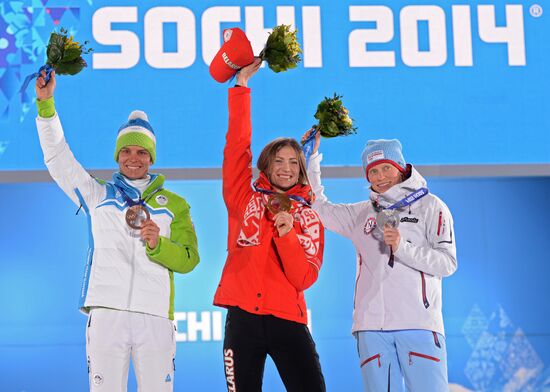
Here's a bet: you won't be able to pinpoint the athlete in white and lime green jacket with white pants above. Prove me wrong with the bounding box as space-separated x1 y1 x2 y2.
36 73 199 392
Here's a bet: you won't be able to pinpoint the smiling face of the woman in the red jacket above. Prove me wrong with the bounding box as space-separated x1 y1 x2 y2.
266 146 300 191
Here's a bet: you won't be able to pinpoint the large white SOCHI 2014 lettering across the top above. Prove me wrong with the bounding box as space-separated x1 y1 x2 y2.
92 4 542 69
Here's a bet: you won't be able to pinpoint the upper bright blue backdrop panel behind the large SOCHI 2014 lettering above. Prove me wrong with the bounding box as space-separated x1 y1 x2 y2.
0 0 550 170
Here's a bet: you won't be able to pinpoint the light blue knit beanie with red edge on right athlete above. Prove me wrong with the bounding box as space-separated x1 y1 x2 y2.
361 139 407 180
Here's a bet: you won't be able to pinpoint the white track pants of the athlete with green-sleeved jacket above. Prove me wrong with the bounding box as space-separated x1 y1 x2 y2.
86 308 176 392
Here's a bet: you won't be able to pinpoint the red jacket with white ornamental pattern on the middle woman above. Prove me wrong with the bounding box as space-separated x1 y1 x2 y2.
214 87 324 324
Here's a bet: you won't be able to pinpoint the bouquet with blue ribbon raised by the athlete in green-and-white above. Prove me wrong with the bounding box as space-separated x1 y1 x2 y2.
19 28 92 97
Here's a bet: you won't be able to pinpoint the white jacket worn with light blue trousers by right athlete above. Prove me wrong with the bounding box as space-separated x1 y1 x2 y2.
308 153 457 335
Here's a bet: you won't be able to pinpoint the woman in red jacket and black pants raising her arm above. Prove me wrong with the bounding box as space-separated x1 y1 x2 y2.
214 60 325 391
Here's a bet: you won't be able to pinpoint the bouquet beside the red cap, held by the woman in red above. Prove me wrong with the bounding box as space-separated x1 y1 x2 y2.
259 25 302 72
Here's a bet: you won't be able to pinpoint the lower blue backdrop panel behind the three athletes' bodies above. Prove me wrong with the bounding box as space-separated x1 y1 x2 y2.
0 178 550 392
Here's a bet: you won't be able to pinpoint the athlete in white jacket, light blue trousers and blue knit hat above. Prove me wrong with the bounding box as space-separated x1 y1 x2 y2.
304 131 457 392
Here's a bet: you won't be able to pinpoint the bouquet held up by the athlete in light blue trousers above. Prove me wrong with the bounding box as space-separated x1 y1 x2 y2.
302 93 357 162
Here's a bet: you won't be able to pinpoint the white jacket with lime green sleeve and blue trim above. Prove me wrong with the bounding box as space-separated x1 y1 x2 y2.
36 114 199 319
